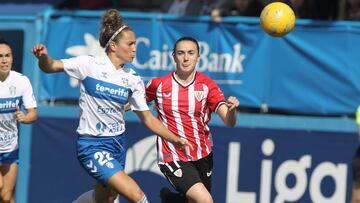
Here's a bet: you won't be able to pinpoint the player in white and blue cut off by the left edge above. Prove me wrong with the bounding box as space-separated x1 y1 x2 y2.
0 39 37 203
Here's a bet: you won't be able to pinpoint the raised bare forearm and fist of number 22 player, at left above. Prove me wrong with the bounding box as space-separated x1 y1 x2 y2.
32 44 64 73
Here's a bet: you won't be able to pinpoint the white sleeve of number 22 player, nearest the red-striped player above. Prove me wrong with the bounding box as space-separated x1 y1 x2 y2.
129 77 149 111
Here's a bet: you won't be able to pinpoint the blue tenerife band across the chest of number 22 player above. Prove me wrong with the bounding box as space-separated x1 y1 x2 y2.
83 77 131 104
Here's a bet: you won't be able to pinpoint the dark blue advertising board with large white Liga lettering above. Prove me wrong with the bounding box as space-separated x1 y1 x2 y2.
28 117 357 203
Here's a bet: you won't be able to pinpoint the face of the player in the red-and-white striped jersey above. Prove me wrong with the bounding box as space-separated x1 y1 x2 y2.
173 40 199 74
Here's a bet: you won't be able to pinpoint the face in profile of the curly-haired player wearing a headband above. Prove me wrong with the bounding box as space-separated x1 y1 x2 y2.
115 30 136 63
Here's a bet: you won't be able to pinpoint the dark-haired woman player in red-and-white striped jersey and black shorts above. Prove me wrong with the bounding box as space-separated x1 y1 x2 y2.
146 37 239 203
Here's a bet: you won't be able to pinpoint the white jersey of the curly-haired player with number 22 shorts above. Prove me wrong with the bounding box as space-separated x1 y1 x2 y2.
62 56 149 136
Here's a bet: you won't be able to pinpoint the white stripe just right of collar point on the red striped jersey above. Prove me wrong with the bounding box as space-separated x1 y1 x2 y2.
188 83 204 159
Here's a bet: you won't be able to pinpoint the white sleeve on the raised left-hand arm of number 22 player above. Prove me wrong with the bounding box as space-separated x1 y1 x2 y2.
61 56 91 80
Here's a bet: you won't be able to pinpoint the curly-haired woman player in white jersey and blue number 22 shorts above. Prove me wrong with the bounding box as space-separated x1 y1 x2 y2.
33 9 192 203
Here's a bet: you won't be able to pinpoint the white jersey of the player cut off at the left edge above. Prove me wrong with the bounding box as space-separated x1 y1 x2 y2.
0 71 37 153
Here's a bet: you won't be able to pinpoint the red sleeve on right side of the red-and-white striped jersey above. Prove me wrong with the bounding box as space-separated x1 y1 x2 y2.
207 79 226 112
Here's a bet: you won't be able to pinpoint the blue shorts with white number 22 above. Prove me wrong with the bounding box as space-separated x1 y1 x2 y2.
77 135 126 184
